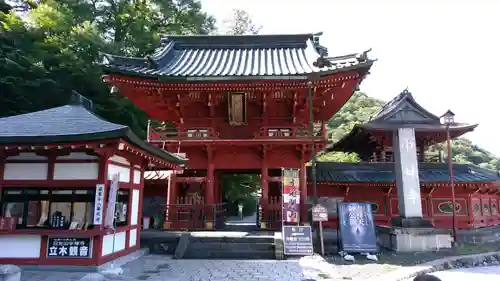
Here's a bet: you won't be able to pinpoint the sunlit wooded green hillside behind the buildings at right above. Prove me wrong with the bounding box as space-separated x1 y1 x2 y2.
318 92 500 170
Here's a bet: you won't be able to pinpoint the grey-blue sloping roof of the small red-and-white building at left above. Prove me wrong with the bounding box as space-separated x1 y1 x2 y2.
0 100 187 164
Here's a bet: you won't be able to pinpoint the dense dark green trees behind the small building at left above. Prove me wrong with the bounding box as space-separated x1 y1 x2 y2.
0 0 215 137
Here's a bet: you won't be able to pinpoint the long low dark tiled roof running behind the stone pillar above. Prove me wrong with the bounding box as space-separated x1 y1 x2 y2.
307 162 500 183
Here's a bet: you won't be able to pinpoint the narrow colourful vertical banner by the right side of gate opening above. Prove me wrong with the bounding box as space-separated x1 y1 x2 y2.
282 168 300 222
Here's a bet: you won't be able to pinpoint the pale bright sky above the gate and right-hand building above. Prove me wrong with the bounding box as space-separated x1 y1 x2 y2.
201 0 500 155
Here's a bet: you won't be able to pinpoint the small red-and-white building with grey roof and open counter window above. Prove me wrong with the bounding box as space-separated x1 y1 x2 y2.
0 95 186 266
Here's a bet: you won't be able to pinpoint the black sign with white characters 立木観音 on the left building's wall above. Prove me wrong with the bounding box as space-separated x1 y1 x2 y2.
47 237 92 258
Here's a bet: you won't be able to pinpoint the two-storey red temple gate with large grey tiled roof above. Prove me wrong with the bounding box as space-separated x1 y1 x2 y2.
102 34 373 229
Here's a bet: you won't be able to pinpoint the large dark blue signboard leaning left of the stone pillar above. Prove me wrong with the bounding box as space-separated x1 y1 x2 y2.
338 202 378 253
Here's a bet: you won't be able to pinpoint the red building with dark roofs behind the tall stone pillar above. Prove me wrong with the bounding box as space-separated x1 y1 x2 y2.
316 90 500 229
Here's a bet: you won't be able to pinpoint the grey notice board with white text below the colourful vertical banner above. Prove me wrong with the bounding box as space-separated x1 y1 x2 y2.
283 225 314 256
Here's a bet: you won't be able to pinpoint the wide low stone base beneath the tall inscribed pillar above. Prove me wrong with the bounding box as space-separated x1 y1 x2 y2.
377 226 453 252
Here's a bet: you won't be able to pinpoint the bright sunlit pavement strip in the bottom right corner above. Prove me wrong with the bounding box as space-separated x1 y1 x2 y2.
433 266 500 281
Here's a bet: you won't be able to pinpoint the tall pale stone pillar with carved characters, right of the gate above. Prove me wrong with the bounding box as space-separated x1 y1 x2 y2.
392 128 432 227
